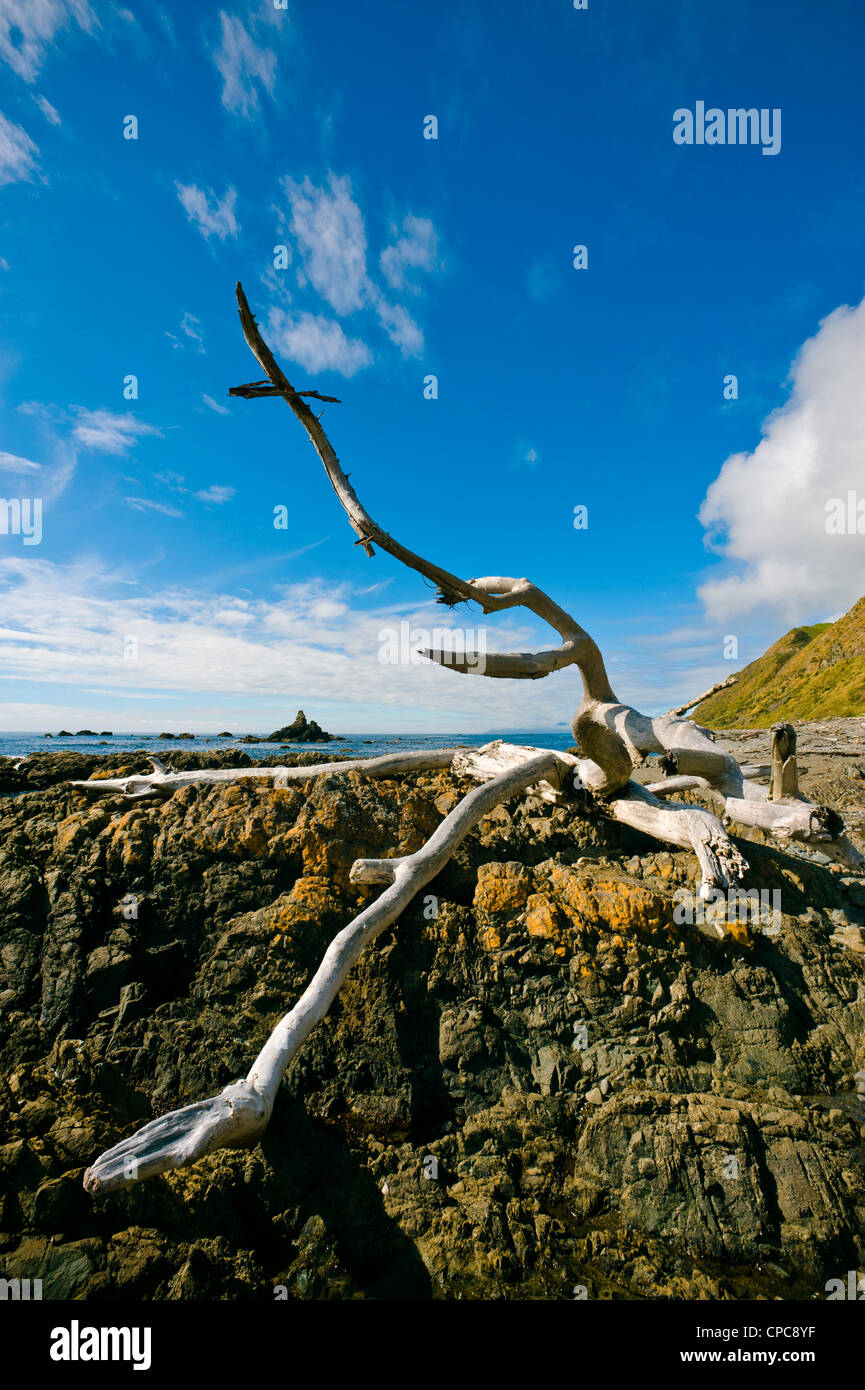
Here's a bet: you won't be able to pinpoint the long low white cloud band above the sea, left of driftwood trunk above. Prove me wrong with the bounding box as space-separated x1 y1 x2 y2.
0 558 577 728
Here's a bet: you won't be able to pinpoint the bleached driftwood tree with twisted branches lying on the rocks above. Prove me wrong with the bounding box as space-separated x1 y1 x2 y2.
74 284 862 1193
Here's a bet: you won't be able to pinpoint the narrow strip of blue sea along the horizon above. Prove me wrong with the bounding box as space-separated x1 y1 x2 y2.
0 726 584 759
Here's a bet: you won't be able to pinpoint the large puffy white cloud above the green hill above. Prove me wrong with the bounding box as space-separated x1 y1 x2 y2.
700 300 865 621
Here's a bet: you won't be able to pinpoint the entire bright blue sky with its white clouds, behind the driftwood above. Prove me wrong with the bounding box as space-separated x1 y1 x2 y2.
0 0 865 733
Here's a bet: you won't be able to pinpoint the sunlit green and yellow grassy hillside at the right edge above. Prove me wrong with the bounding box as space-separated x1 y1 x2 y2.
691 598 865 728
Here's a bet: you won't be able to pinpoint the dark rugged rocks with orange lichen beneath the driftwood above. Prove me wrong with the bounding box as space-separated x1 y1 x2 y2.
0 721 865 1300
